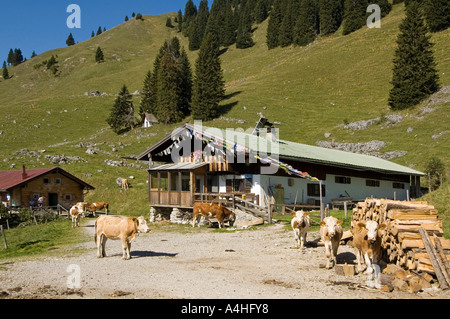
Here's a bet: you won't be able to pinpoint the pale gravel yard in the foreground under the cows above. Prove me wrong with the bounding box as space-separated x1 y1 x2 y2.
0 220 450 299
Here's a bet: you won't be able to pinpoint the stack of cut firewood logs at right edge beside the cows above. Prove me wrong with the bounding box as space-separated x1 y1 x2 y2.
352 198 450 274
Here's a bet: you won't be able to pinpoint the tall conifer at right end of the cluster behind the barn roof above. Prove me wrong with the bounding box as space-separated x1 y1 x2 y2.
191 33 225 121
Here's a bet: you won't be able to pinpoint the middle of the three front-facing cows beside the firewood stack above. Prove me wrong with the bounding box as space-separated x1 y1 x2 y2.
320 216 344 269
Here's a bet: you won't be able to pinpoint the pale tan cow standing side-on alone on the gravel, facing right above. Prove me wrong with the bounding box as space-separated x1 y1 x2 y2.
94 215 150 260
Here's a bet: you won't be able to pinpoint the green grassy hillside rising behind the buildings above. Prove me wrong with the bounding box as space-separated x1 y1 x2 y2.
0 4 450 219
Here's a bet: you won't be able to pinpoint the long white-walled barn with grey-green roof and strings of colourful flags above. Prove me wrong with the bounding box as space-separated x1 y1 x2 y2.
138 118 424 214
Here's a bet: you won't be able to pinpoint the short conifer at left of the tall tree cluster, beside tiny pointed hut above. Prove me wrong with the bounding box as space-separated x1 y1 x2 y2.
106 85 135 134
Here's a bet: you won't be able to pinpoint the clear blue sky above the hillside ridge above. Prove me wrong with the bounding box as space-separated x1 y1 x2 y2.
0 0 200 67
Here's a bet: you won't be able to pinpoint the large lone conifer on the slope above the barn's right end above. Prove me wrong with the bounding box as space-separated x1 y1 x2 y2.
389 2 439 110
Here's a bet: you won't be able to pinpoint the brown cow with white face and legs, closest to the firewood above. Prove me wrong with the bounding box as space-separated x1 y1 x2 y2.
353 220 386 288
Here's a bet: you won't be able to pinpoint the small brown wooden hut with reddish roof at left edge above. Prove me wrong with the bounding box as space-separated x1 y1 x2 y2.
0 165 95 209
